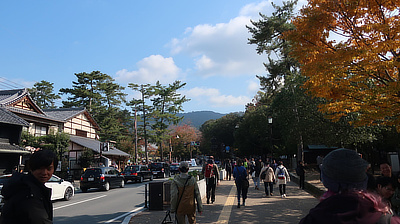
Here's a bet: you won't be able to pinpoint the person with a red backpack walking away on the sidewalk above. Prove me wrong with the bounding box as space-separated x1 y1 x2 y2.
203 157 219 204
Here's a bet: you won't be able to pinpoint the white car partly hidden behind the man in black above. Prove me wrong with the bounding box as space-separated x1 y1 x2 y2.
44 175 75 201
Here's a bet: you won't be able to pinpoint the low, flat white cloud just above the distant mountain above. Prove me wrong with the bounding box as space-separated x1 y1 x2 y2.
183 87 251 108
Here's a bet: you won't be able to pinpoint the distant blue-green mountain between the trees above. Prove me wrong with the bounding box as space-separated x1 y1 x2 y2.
177 111 226 128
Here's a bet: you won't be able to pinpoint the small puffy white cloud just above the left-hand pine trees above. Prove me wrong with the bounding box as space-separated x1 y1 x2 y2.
115 55 180 84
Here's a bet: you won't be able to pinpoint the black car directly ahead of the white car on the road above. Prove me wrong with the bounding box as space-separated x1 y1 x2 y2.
80 167 125 192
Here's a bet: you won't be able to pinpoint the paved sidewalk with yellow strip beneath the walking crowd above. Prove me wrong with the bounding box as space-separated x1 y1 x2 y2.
129 174 318 224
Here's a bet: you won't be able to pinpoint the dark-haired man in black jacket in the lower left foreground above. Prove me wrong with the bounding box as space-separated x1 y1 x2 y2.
0 150 57 224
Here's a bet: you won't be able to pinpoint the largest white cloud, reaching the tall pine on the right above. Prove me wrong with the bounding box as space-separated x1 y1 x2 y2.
169 7 267 76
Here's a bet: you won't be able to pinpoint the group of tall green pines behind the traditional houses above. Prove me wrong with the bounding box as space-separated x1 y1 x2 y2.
29 71 189 164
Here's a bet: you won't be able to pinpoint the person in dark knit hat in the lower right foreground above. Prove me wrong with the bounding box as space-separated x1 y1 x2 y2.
300 148 400 224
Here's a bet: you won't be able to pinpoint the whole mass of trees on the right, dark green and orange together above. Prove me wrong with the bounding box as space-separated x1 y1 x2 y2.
200 0 400 166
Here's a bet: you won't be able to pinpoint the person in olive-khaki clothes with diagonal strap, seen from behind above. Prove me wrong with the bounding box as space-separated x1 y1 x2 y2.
171 162 203 224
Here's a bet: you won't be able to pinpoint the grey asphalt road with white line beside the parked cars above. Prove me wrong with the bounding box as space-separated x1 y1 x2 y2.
53 179 158 224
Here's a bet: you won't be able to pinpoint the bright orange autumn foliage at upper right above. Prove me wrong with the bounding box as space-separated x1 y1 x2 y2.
283 0 400 131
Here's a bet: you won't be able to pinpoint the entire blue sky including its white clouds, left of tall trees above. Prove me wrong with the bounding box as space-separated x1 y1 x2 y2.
0 0 306 113
